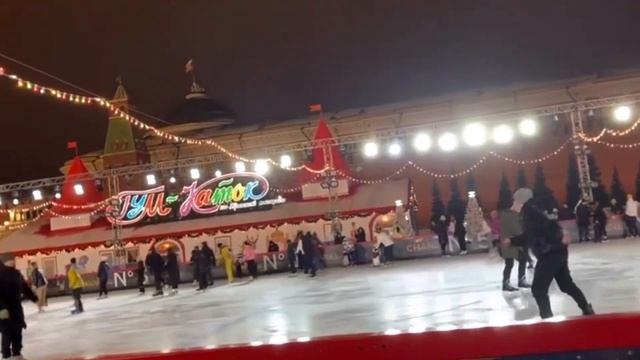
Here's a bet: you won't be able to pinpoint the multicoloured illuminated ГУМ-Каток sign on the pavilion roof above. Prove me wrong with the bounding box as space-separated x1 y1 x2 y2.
106 172 285 225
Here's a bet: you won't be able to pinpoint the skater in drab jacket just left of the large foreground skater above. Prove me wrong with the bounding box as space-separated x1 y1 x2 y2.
499 204 531 291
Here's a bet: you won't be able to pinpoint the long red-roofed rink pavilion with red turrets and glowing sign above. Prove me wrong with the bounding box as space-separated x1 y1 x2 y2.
0 121 424 295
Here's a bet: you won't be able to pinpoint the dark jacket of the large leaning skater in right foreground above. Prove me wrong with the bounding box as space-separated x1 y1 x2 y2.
516 200 568 258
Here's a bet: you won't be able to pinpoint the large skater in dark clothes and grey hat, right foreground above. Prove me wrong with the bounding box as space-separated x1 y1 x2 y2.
505 188 594 319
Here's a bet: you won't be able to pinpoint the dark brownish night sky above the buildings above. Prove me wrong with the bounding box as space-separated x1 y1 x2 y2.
0 0 640 183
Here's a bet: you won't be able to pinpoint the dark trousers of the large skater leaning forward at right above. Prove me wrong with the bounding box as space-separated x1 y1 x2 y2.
531 254 589 319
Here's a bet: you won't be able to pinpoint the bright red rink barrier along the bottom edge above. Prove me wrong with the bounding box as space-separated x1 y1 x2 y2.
77 314 640 360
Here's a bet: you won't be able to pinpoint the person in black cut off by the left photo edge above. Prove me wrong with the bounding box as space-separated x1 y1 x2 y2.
0 254 38 359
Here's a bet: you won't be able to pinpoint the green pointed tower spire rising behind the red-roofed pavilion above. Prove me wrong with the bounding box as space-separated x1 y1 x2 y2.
103 77 148 169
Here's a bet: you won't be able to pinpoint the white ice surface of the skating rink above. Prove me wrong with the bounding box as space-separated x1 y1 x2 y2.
24 239 640 359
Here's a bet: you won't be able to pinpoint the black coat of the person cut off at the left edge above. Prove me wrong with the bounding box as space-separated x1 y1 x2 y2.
0 264 38 329
